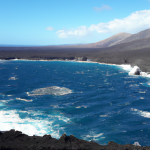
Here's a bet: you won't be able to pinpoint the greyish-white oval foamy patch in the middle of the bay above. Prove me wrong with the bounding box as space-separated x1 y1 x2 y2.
27 86 72 96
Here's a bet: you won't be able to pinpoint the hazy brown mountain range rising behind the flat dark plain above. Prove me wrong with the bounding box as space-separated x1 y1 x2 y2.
62 29 150 51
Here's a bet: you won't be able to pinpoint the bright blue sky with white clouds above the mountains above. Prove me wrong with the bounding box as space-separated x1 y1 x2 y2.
0 0 150 46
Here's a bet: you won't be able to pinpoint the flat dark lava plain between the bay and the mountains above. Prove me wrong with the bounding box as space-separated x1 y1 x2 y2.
0 46 150 72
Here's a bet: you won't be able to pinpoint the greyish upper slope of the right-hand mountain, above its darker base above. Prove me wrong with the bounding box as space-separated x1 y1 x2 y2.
111 29 150 46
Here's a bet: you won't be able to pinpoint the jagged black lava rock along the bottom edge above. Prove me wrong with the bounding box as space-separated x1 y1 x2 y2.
0 130 150 150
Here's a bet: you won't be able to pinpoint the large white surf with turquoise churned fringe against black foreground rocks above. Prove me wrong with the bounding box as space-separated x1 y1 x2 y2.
0 110 69 138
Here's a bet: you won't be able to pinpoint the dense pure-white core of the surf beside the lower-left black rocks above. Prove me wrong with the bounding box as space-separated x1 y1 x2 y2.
0 111 46 135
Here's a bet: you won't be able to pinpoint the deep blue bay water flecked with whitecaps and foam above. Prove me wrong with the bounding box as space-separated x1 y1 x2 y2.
0 60 150 146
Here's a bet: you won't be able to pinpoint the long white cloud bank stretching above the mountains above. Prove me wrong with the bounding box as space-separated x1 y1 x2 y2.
56 10 150 38
